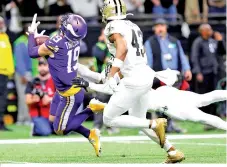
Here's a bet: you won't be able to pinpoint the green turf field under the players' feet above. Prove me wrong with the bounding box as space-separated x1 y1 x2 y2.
0 122 226 164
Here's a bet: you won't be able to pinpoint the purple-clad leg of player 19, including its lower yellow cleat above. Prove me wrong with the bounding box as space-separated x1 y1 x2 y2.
54 90 101 156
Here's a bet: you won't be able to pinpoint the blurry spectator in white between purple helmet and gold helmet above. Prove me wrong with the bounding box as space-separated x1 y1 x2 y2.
68 0 101 23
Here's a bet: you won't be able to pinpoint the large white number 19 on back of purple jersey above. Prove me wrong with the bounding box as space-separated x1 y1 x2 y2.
67 47 80 73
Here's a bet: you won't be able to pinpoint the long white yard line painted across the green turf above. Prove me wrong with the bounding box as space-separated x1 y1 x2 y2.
0 134 227 144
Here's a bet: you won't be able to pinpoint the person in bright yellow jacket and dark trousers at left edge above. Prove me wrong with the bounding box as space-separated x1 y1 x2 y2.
0 17 14 131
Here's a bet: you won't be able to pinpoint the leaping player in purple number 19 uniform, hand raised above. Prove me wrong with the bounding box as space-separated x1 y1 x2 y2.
28 14 101 156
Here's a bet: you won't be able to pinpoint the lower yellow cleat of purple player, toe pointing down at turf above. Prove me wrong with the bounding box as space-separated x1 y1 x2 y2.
88 129 101 157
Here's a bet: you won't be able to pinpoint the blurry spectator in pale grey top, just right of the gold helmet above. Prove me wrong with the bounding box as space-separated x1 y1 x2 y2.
124 0 145 14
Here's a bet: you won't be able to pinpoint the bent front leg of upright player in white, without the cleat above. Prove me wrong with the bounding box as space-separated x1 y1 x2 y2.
103 85 163 129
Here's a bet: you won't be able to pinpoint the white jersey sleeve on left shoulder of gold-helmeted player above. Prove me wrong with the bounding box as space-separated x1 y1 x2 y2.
104 20 124 37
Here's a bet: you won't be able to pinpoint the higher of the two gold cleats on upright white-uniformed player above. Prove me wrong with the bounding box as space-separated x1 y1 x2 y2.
154 118 167 148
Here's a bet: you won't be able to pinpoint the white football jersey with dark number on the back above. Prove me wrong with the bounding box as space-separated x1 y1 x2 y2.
104 20 147 77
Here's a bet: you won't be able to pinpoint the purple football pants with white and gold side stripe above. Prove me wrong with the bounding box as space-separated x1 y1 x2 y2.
50 89 93 138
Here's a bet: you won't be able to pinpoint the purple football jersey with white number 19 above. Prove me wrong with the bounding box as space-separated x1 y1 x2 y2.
45 35 80 92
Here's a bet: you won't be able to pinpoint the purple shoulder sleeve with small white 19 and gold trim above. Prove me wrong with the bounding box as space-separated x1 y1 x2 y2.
45 35 62 53
